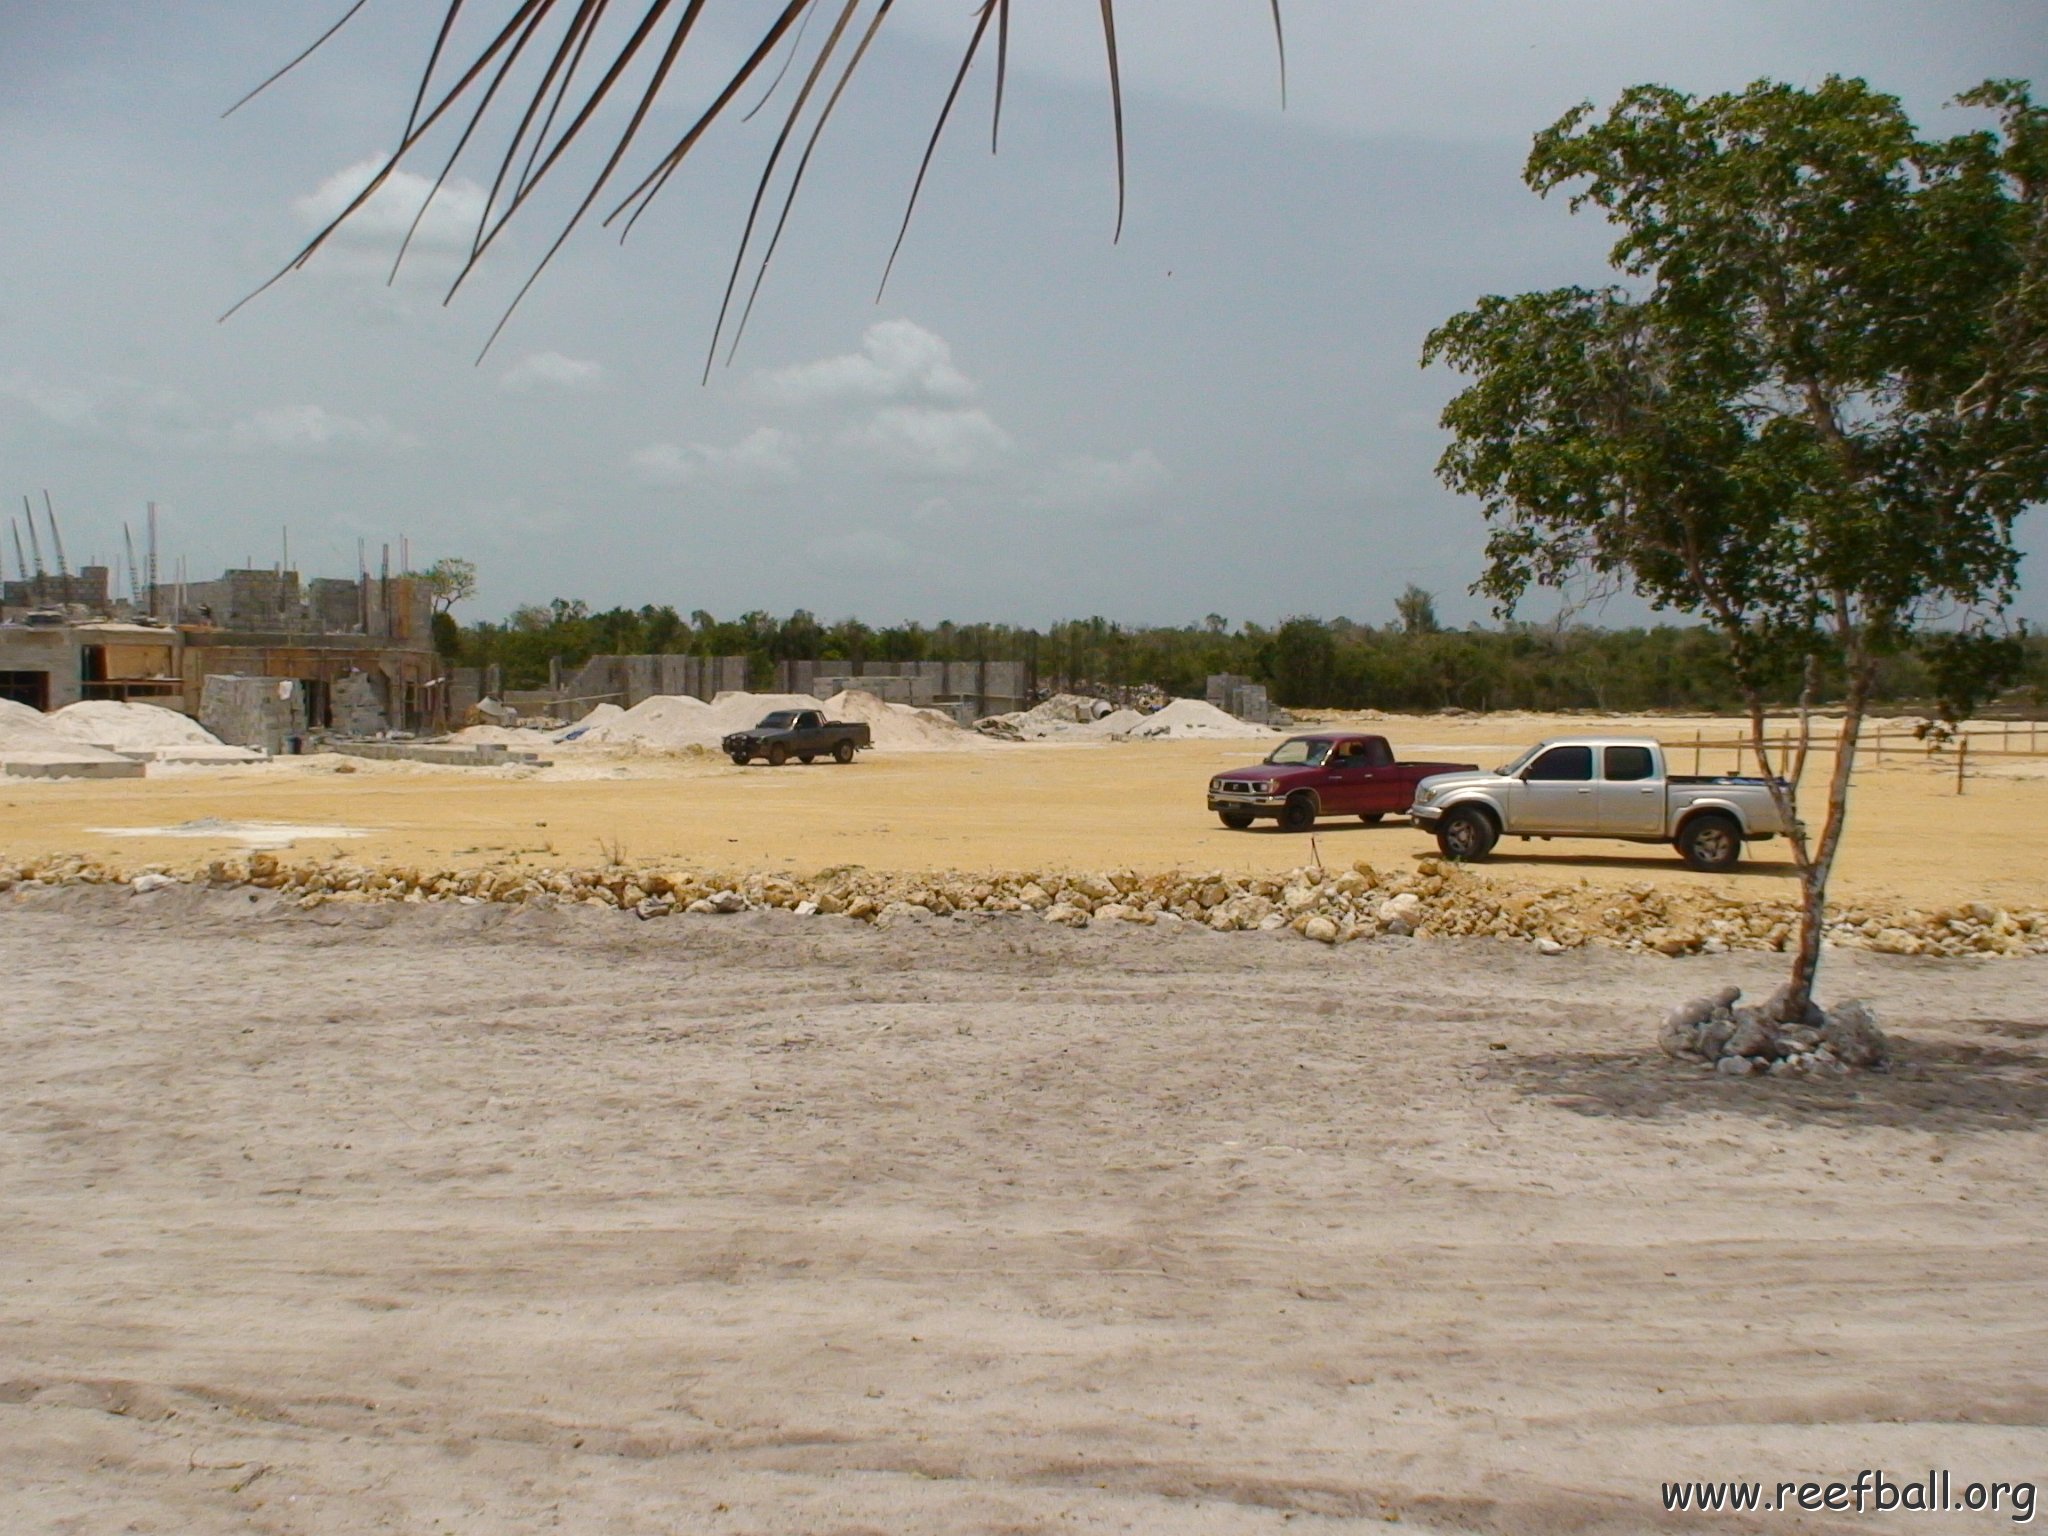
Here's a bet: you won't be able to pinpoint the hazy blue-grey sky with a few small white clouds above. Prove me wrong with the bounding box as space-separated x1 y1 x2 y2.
0 0 2048 625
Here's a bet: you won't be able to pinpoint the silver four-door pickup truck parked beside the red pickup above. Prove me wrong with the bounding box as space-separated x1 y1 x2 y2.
1409 735 1786 870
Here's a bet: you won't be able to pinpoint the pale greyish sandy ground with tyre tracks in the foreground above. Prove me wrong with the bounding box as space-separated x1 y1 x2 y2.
0 888 2048 1536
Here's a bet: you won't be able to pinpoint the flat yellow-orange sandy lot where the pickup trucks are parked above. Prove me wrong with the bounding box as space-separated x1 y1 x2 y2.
0 717 2048 921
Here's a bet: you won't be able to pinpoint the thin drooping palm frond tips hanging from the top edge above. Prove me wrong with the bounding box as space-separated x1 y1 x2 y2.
223 0 1286 362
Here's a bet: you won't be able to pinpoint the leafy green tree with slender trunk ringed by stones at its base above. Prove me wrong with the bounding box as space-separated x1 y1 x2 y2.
1423 78 2048 1012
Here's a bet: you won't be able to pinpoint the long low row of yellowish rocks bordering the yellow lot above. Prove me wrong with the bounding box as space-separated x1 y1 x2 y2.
0 852 2048 956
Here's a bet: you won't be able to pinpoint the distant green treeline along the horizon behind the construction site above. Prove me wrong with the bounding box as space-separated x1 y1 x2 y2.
452 592 2048 711
